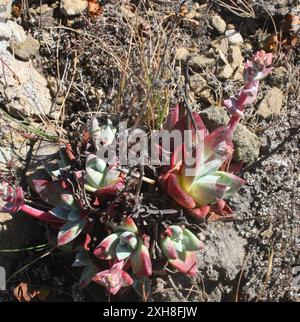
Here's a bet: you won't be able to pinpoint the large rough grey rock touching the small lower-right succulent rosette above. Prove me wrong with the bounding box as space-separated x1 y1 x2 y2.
197 223 247 282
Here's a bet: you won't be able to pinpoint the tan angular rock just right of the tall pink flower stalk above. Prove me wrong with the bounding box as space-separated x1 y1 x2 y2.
256 87 283 118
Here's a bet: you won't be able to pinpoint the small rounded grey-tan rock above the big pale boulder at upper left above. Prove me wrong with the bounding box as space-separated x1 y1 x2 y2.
9 36 40 60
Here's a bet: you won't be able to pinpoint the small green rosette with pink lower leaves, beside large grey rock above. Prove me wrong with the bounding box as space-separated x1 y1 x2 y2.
160 225 203 276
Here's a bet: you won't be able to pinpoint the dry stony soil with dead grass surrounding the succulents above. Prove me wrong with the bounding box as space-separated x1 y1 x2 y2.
0 0 300 301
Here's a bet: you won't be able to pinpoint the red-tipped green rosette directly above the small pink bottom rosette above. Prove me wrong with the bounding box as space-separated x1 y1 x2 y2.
94 217 152 277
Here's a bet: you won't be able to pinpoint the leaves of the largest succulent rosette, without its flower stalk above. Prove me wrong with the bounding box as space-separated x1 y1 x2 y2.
160 105 244 218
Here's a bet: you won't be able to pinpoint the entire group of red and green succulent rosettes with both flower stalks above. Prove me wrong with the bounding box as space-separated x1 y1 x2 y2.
0 51 272 295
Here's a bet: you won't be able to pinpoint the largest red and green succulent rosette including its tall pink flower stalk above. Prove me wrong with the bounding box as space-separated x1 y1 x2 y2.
160 51 272 219
